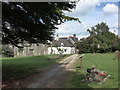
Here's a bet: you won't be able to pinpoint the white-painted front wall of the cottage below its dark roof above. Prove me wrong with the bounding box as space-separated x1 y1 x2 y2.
48 47 75 54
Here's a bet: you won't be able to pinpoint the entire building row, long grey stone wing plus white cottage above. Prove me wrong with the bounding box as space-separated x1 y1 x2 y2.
14 35 79 57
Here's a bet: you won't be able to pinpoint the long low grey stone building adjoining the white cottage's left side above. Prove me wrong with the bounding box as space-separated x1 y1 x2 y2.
14 44 48 57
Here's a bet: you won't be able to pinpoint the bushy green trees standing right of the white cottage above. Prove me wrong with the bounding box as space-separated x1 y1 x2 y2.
77 22 120 53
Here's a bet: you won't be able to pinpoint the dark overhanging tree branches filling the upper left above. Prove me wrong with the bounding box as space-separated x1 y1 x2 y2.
1 2 80 47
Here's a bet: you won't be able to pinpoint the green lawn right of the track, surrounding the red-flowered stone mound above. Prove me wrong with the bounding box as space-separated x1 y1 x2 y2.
67 53 118 88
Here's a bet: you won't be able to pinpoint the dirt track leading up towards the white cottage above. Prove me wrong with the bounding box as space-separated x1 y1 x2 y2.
7 54 78 88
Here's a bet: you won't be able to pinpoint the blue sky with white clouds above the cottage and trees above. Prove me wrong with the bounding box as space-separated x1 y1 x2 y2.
56 0 118 39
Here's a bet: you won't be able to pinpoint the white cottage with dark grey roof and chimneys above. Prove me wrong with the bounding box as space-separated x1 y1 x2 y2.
48 34 78 54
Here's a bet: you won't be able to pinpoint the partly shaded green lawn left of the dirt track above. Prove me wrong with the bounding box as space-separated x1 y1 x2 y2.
2 55 70 82
